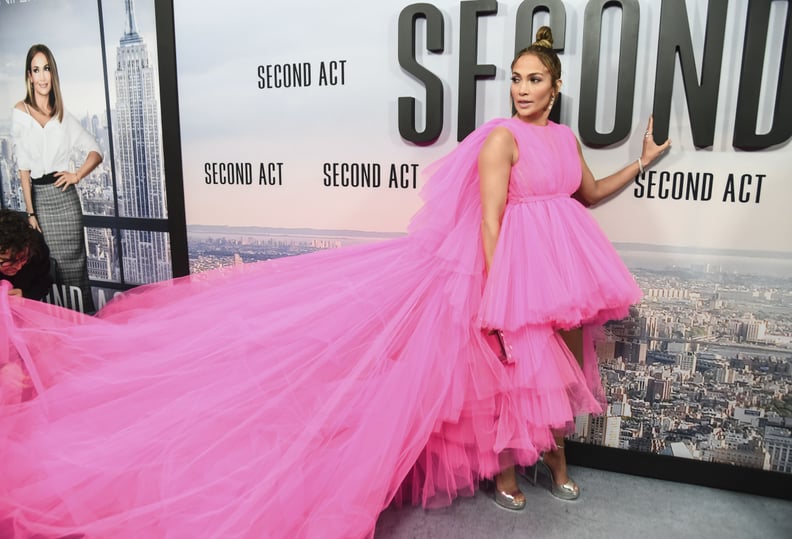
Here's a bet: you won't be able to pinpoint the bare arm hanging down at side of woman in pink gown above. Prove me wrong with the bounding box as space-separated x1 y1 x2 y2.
478 127 517 272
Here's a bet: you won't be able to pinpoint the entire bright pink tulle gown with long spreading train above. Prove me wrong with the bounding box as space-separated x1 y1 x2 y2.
0 119 640 539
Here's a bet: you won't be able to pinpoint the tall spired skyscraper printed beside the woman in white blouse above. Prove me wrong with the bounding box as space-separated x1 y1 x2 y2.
114 0 171 284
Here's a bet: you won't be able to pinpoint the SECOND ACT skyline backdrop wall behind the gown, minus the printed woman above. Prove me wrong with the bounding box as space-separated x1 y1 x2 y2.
0 0 792 480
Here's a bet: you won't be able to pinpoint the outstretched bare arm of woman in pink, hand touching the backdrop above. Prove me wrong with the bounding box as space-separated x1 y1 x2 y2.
576 116 671 206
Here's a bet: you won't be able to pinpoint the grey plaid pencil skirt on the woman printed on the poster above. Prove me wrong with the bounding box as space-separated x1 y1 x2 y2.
32 184 96 313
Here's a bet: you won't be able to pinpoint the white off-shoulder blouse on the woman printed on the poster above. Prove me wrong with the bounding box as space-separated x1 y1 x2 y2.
11 108 102 178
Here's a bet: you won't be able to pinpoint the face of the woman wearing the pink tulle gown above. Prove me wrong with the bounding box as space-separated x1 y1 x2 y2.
511 54 561 125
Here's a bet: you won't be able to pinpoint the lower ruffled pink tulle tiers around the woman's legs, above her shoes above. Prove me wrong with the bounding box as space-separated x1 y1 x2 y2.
395 326 604 507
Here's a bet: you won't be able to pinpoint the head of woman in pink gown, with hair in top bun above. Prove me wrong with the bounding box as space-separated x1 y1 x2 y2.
511 26 561 125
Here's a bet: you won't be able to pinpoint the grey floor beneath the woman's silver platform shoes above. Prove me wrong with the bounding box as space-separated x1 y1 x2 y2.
375 466 792 539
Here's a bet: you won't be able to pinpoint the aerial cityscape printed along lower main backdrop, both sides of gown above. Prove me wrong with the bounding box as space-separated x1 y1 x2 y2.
188 225 792 473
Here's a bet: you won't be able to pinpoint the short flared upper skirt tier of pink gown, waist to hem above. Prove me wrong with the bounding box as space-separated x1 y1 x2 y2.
479 197 641 331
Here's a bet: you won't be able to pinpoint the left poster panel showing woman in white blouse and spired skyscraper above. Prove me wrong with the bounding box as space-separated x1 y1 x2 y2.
0 0 172 312
